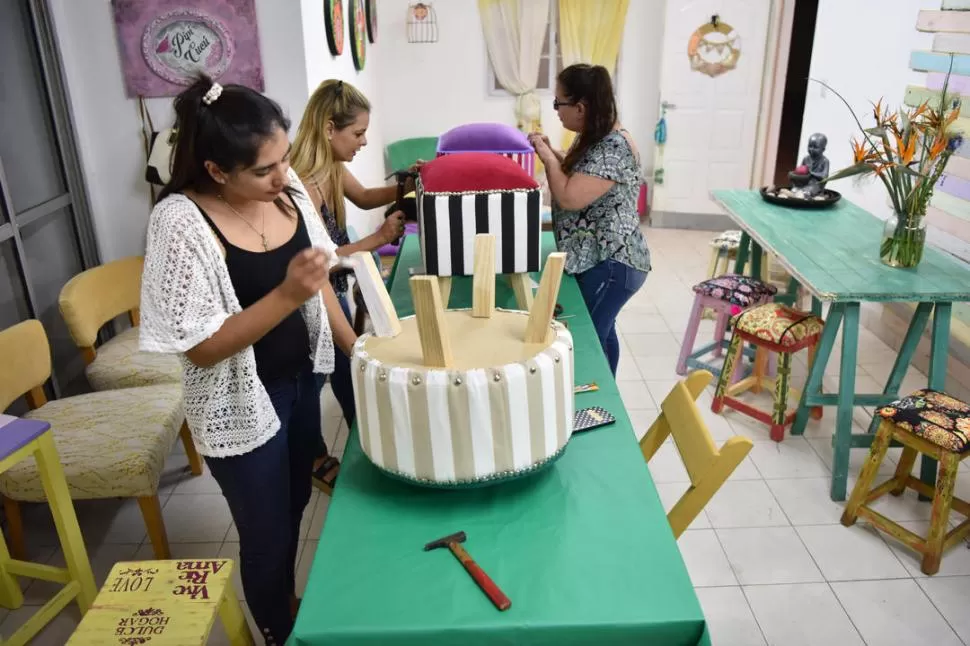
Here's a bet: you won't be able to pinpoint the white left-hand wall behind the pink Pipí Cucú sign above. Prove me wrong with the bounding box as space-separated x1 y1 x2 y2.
50 0 387 261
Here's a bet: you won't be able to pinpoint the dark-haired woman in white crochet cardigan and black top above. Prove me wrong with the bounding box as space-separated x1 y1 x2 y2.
140 78 356 644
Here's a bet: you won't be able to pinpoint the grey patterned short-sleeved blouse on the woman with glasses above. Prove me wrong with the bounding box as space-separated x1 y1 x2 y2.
552 130 650 274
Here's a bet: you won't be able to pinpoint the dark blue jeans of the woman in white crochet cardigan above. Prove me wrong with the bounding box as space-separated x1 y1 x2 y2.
205 367 320 644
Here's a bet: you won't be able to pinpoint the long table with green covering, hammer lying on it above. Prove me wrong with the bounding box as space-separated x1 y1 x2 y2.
290 234 710 646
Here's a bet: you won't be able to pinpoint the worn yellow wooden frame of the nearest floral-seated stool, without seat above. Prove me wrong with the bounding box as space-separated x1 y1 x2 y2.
842 420 970 575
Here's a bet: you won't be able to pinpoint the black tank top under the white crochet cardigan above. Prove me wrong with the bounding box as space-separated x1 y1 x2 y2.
196 204 312 384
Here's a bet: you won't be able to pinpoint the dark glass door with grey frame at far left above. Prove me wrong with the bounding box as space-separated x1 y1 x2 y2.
0 0 99 414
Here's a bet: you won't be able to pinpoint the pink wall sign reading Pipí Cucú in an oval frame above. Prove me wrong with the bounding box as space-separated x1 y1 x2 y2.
111 0 263 97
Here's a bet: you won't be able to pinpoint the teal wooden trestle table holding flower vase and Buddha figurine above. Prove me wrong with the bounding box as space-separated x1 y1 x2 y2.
712 190 970 500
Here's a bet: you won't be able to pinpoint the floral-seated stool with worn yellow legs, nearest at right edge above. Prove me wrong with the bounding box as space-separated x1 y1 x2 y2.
842 390 970 575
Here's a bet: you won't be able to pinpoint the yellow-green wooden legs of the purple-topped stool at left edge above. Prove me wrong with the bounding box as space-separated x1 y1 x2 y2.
0 429 97 646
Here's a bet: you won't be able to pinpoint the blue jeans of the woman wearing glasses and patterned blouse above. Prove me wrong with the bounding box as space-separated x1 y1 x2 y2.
576 260 647 377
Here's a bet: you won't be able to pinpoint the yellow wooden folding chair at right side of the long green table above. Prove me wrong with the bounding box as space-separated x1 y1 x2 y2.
640 370 753 538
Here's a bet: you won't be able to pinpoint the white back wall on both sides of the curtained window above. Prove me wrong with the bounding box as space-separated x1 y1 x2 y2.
380 0 666 177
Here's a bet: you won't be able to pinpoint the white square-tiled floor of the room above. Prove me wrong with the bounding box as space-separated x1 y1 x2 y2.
7 230 970 646
